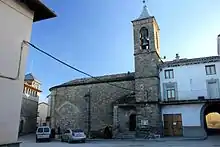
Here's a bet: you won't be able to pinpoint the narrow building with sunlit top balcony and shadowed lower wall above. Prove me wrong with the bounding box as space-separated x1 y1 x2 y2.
19 73 41 135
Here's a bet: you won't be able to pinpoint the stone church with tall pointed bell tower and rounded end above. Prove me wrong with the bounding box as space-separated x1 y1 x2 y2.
50 5 163 137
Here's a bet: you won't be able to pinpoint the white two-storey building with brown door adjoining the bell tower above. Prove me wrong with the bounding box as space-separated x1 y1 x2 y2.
160 50 220 137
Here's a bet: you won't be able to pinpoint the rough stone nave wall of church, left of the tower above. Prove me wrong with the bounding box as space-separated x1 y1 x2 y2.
51 80 134 136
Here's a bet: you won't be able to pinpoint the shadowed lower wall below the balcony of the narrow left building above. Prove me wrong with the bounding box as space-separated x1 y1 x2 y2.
19 95 38 135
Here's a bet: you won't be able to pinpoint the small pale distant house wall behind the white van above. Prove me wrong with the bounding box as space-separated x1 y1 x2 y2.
37 103 48 125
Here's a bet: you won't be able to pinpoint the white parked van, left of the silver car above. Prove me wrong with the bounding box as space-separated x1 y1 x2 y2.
36 126 51 142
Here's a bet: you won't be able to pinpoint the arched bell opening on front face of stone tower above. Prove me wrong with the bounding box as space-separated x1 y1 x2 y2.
140 27 149 49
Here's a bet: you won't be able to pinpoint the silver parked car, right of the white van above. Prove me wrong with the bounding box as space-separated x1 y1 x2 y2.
61 129 86 143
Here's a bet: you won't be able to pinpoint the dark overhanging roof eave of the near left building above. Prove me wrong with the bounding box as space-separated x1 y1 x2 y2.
17 0 57 22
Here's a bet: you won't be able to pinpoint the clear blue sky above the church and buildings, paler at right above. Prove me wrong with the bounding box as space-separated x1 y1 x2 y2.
26 0 220 101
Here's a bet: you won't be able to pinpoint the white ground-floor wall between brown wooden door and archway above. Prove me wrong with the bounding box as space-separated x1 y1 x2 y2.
162 104 203 126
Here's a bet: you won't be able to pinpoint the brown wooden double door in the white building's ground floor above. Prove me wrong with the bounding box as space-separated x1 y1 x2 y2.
163 114 183 136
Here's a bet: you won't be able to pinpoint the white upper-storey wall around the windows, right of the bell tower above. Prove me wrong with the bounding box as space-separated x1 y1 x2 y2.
160 62 220 100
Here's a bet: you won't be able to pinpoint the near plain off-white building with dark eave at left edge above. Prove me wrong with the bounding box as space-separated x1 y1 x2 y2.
0 0 55 145
